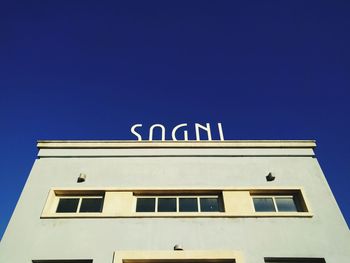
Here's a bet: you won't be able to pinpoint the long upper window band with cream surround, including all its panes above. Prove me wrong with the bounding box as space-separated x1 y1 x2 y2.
41 188 313 218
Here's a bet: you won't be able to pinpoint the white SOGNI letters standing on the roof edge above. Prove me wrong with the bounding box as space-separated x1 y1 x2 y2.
131 123 224 141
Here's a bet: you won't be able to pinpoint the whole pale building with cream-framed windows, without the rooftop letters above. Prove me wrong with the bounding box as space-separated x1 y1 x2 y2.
0 141 350 263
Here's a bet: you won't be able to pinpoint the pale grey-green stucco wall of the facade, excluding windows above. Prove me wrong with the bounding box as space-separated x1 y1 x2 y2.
0 145 350 263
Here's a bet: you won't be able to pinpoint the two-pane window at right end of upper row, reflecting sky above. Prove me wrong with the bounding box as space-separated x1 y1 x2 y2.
252 194 306 212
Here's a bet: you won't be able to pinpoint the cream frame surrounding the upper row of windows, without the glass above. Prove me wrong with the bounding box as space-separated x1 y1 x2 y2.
40 187 313 219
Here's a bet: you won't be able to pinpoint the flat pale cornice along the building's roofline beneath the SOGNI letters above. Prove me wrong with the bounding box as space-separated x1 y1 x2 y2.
37 140 316 158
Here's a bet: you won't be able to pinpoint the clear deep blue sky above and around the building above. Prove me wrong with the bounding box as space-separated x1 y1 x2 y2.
0 0 350 239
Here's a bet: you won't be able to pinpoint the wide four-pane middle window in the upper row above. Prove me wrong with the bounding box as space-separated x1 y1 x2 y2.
136 195 224 213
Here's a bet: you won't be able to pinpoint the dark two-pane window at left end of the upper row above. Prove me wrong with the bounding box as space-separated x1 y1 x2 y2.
56 196 103 213
